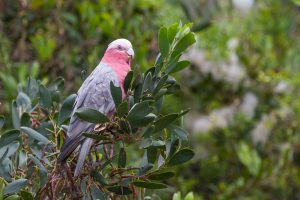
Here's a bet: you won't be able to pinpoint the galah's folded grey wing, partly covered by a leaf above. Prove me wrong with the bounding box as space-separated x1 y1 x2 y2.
58 65 119 163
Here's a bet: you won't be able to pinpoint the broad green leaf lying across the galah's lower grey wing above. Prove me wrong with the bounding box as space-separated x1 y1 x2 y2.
75 107 109 124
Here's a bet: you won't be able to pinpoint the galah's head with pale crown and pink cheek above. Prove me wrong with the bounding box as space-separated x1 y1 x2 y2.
105 38 134 64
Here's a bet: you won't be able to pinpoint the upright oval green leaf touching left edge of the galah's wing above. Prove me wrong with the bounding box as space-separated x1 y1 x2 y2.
58 94 77 125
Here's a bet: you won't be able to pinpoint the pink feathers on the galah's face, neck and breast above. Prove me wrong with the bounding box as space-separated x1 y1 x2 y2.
101 49 131 98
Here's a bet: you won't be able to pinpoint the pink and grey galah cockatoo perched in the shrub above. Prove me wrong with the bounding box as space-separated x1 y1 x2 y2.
58 39 134 177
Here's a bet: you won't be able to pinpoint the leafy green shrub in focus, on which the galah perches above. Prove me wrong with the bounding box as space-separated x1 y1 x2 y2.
0 24 195 199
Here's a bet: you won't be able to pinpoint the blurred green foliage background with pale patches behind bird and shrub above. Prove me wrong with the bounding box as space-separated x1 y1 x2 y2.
0 0 300 199
